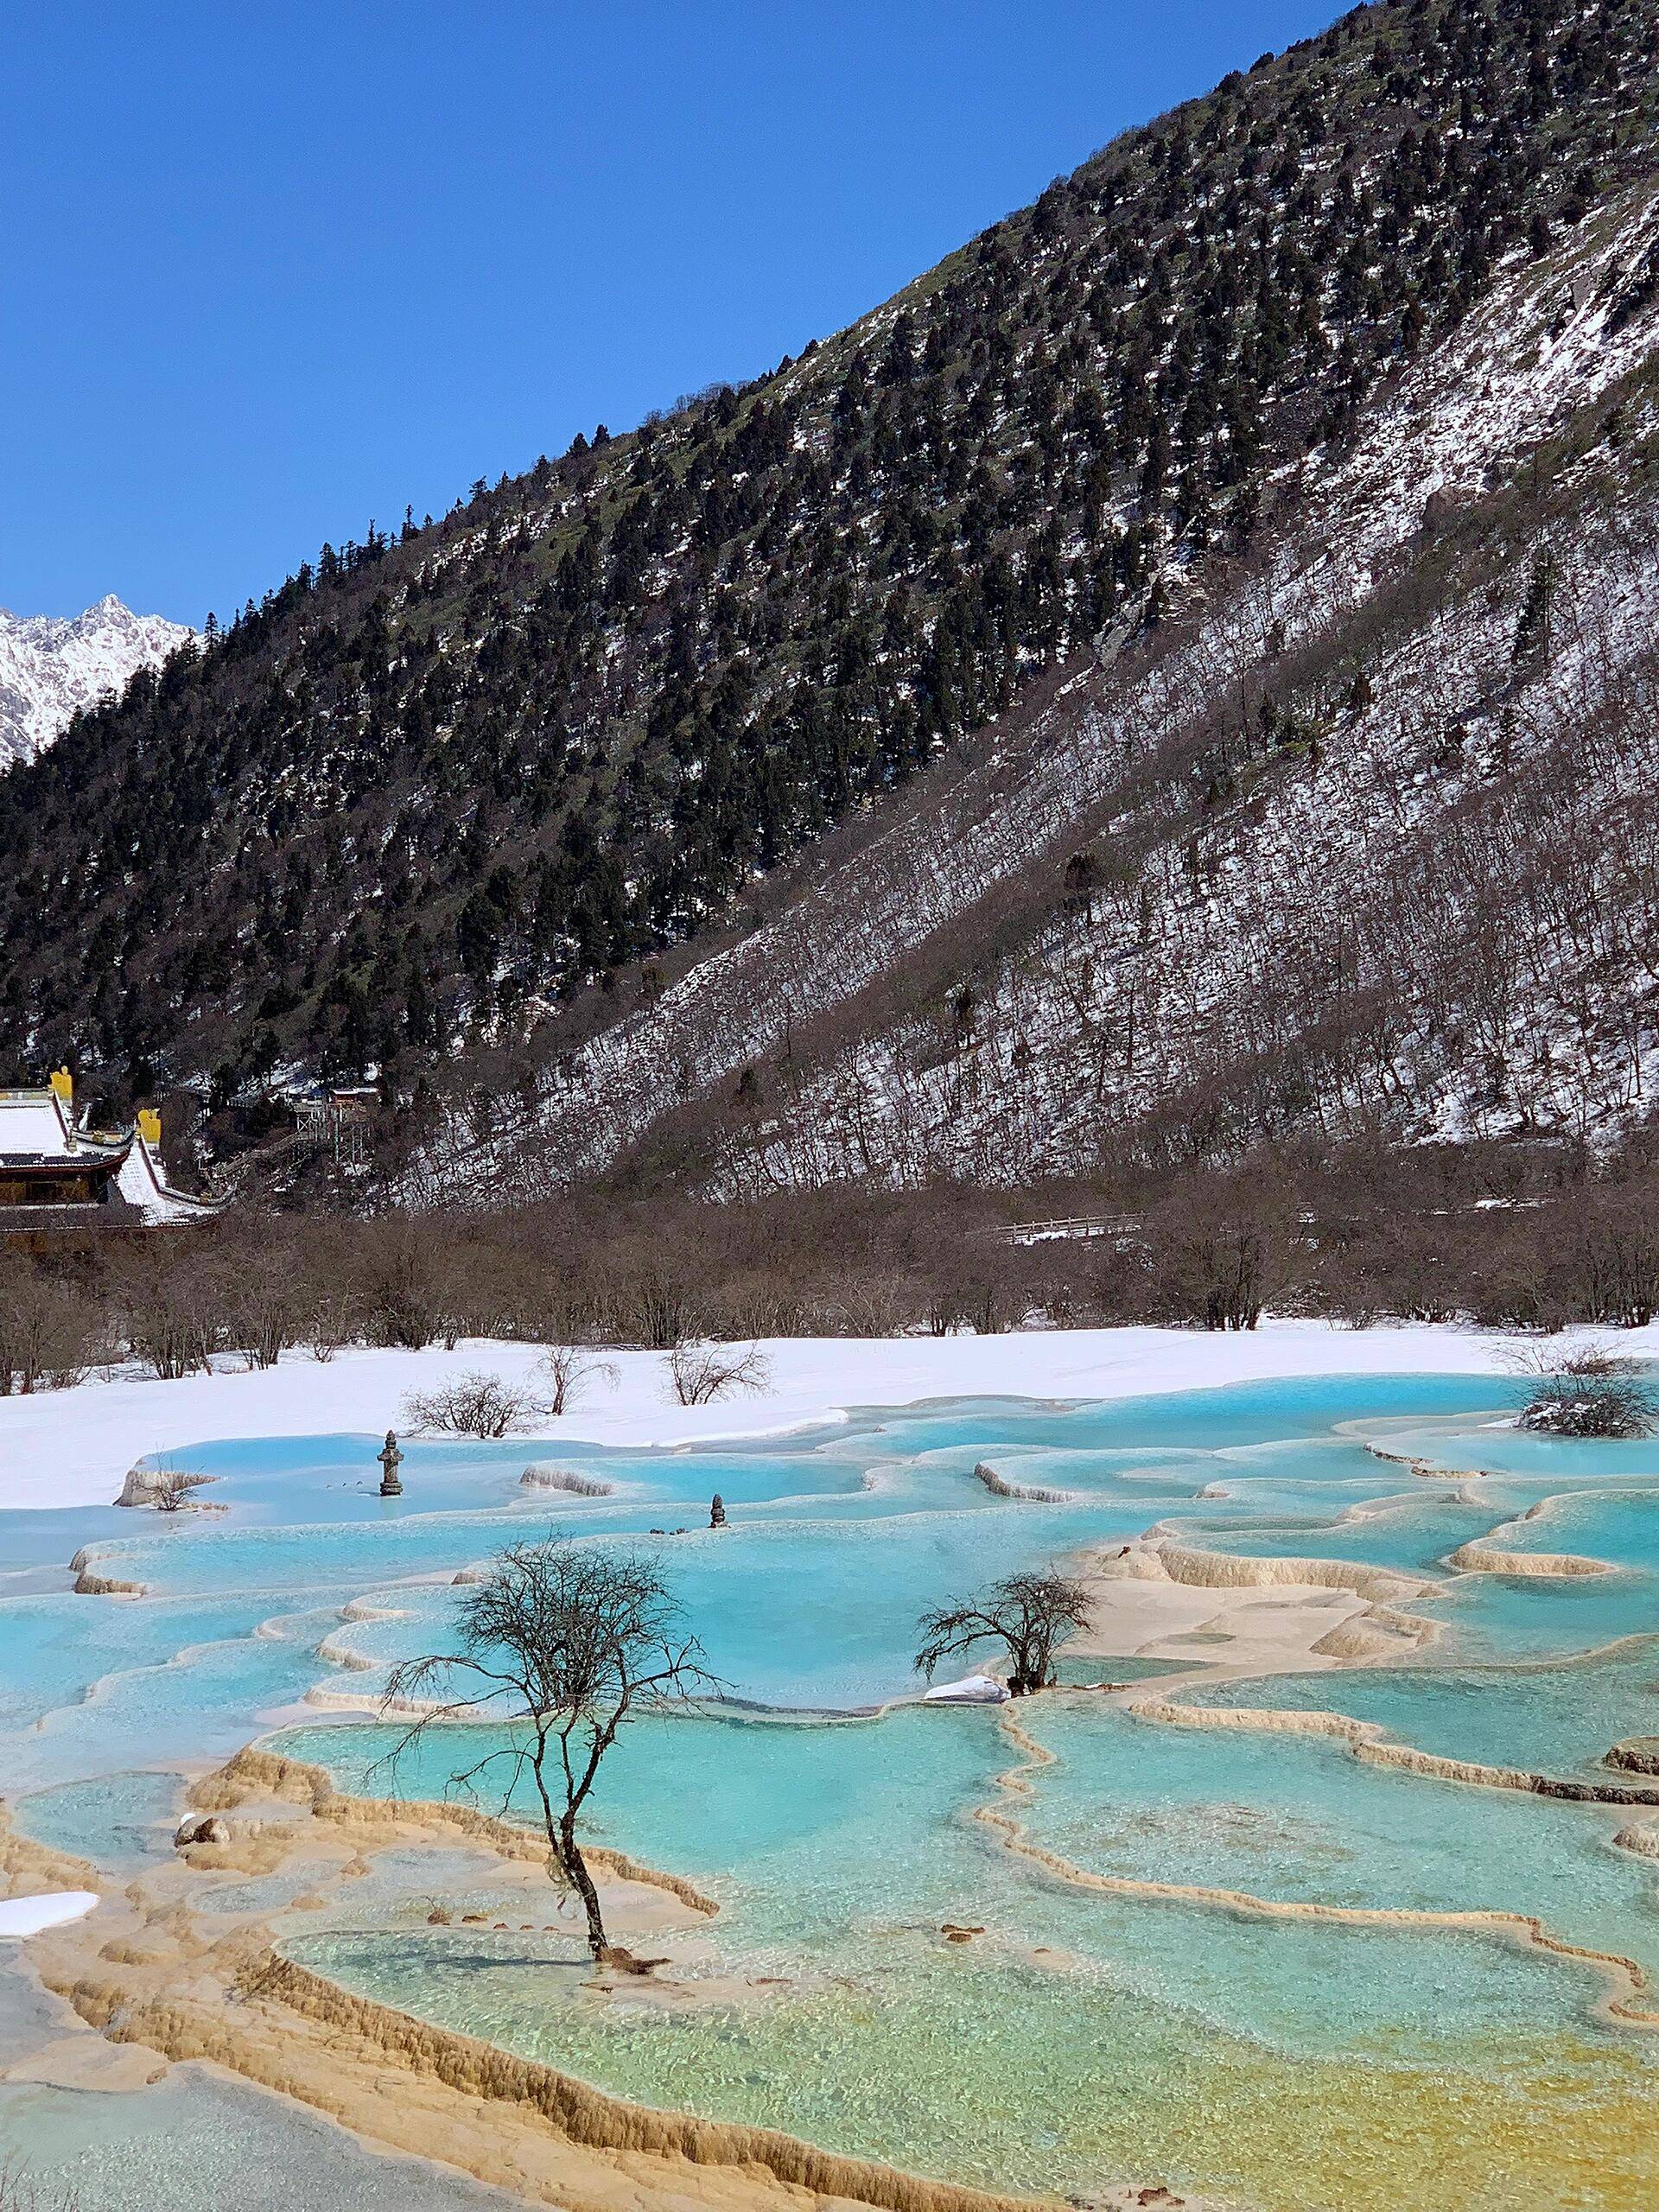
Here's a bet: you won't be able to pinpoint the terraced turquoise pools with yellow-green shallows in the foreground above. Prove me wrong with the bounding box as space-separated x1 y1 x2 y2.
0 1376 1659 2212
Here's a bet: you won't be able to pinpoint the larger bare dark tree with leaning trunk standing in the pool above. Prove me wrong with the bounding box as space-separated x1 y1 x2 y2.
385 1544 716 1967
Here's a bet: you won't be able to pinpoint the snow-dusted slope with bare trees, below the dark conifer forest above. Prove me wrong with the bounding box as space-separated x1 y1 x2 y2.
398 188 1659 1204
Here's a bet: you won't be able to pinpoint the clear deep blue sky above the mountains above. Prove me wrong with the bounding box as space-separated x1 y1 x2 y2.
0 0 1340 621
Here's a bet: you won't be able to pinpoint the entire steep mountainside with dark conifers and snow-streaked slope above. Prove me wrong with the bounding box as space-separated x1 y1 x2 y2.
0 0 1659 1197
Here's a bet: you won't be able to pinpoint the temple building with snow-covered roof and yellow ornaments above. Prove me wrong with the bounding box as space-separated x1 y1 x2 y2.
0 1068 217 1243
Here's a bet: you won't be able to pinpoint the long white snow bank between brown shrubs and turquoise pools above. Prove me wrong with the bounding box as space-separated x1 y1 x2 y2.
0 1320 1574 1506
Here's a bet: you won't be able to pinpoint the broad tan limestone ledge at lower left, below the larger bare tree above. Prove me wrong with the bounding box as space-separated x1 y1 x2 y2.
19 1747 1211 2212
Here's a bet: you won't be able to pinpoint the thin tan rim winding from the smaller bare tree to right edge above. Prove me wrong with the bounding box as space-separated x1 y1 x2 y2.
973 1710 1659 2029
